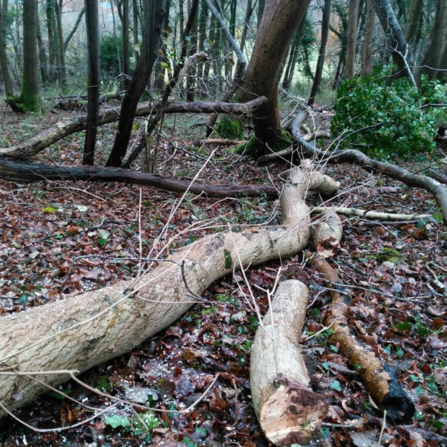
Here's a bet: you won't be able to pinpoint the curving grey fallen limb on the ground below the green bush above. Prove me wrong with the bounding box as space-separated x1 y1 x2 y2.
291 112 447 223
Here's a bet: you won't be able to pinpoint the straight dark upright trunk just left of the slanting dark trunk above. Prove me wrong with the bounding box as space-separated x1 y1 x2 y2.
82 0 100 166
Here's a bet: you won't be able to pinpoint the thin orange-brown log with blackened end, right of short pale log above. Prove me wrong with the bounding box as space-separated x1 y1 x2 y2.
316 258 415 422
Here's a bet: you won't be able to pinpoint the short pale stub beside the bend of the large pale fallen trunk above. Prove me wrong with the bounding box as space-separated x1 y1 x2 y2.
313 209 343 258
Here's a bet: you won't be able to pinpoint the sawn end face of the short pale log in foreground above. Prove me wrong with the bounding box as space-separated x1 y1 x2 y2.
259 383 328 446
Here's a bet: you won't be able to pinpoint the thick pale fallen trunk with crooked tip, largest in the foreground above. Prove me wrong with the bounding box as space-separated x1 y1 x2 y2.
0 162 337 420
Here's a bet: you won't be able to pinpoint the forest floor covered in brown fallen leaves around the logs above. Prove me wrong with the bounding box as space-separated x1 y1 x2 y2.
0 101 447 447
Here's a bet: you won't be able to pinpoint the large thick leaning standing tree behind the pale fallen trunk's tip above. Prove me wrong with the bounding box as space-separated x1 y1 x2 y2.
240 0 309 154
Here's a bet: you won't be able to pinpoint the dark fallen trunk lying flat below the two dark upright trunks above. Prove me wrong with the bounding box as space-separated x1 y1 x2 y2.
0 157 278 198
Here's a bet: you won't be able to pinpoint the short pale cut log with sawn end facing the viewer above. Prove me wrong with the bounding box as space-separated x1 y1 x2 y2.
250 280 328 445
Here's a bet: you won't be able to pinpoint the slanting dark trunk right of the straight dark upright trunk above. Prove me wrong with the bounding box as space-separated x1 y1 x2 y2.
107 0 166 167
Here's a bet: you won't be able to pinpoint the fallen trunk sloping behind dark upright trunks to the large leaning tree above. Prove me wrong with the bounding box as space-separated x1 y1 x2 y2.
0 97 267 160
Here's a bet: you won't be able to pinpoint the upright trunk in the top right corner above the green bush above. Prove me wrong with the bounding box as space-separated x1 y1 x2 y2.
419 0 447 79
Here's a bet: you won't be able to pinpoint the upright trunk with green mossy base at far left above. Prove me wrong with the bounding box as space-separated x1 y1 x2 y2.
17 0 40 113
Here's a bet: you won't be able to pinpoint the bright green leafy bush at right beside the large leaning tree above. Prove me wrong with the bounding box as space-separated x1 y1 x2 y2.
331 66 445 159
